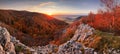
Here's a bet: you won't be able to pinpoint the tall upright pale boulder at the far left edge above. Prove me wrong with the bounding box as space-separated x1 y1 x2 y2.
0 27 16 54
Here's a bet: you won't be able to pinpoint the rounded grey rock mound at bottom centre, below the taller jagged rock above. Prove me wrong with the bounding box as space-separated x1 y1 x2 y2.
58 41 82 54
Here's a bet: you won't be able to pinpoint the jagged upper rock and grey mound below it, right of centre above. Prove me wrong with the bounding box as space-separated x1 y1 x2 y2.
58 24 94 54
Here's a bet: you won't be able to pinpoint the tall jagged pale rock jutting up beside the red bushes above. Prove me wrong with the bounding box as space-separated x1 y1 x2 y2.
71 24 94 41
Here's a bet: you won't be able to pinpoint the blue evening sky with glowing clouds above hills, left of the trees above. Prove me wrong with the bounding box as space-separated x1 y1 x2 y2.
0 0 101 15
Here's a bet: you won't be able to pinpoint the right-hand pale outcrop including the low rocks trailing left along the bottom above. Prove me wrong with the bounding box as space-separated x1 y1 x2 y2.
35 24 95 54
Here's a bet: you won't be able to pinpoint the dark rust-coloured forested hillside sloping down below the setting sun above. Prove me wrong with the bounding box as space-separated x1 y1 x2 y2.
0 10 68 46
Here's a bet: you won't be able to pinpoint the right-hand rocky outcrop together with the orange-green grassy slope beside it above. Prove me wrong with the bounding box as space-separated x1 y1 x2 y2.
35 24 120 54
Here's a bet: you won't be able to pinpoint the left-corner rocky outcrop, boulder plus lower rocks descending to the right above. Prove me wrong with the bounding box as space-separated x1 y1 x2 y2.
0 27 35 54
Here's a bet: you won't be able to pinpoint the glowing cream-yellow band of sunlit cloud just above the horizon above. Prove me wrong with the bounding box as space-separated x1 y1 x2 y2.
27 2 97 15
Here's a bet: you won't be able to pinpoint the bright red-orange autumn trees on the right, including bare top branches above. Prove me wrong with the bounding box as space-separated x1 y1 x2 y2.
82 0 120 34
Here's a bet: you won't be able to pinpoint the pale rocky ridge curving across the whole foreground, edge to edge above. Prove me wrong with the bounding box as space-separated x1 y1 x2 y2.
0 24 120 54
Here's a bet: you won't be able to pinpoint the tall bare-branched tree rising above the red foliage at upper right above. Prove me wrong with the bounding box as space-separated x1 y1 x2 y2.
100 0 120 31
